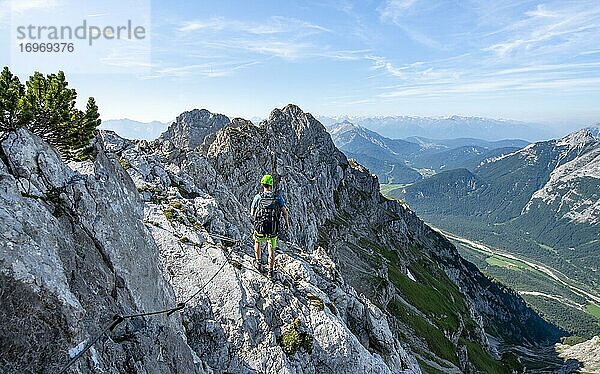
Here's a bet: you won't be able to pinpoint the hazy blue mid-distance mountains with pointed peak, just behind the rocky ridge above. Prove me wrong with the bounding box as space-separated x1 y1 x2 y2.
329 121 529 184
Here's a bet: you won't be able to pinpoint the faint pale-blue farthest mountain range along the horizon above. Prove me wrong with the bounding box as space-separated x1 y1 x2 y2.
318 116 563 141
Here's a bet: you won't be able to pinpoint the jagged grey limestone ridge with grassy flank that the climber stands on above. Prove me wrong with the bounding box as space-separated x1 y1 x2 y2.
0 105 560 374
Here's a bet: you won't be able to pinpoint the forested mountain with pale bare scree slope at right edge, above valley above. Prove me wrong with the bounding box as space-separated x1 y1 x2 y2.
398 127 600 250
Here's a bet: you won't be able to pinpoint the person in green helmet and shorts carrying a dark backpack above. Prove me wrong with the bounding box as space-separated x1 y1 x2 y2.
250 174 290 277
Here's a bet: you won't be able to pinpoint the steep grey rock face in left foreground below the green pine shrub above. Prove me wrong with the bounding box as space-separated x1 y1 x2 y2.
0 130 200 373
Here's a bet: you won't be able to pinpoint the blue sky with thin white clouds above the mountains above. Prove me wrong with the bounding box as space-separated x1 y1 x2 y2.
0 0 600 126
